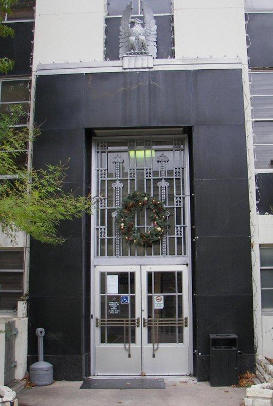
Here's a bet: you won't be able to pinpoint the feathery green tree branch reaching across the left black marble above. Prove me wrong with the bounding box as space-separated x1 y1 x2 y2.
0 107 91 244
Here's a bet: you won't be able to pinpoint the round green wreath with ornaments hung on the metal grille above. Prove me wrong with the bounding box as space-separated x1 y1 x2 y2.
116 192 168 246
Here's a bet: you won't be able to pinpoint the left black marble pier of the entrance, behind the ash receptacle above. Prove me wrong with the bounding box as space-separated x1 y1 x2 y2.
29 129 90 379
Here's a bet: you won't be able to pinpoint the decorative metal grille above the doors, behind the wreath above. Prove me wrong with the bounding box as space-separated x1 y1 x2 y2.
95 136 188 257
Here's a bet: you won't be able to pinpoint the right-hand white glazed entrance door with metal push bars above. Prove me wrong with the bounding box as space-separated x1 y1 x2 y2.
141 265 189 375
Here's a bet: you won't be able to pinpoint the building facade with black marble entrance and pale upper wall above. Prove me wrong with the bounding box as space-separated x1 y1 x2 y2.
0 0 273 380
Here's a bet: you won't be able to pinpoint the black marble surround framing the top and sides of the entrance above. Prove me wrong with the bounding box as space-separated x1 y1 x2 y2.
31 70 254 380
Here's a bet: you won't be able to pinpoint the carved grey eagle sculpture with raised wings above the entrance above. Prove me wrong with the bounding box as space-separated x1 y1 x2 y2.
119 1 157 58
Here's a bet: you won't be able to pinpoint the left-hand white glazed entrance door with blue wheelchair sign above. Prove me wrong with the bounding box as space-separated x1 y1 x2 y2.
96 266 141 375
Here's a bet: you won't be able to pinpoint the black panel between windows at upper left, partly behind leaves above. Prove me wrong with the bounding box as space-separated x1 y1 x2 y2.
0 22 34 75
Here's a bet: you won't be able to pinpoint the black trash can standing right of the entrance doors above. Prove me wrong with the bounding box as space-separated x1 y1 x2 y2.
210 334 238 386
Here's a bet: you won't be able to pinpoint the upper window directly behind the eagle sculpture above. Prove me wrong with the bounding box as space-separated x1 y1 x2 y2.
105 0 174 61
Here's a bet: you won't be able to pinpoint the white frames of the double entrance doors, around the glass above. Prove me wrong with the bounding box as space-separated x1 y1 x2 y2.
93 265 191 376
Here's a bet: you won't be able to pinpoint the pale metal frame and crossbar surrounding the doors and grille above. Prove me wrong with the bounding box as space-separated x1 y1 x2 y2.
90 130 193 376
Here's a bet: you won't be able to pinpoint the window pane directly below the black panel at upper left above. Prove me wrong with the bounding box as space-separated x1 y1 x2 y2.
1 80 30 102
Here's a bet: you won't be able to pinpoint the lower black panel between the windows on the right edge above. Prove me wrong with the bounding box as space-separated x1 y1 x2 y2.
256 173 273 214
